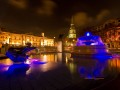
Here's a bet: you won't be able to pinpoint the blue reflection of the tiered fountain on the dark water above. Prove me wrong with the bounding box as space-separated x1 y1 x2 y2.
78 60 106 79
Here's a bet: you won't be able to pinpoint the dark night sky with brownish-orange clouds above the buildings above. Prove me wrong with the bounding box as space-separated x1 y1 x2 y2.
0 0 120 38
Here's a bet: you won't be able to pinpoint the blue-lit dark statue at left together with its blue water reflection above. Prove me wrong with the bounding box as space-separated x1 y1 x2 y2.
6 46 36 75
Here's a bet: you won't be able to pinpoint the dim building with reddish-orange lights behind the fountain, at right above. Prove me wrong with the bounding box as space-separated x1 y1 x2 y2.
91 18 120 48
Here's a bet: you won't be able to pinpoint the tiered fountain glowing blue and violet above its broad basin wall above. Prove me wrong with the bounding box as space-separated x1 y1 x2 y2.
71 32 110 57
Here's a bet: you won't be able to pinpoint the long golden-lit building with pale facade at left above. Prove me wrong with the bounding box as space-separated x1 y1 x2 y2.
0 31 54 46
